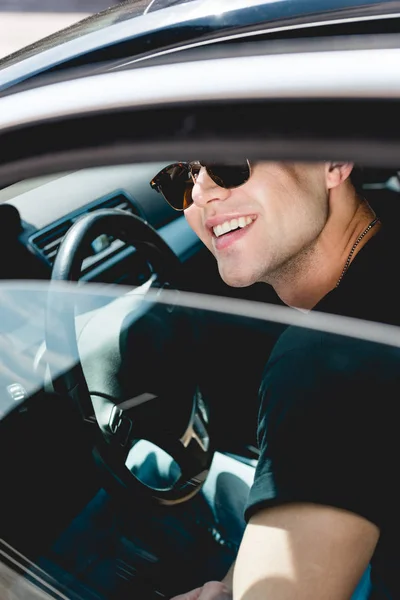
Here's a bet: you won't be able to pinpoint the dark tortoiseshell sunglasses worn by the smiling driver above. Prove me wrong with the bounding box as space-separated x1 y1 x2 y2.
150 160 251 210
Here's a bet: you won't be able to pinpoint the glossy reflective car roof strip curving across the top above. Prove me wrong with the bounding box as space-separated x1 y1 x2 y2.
0 0 400 90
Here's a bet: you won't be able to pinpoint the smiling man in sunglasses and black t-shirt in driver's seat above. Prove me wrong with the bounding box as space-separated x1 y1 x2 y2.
152 162 400 600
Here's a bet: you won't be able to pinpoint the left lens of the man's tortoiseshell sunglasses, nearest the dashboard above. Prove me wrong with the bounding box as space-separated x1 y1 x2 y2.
157 163 193 210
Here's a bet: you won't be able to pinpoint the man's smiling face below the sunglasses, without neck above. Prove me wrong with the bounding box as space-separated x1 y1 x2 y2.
185 162 328 287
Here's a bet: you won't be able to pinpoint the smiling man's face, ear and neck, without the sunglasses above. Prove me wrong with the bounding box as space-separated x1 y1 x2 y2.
185 163 379 308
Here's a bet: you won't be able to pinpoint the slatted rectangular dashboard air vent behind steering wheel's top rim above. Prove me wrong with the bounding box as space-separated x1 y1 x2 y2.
30 194 140 266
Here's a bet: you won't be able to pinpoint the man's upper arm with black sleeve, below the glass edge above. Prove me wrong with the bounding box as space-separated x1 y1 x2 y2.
233 330 390 600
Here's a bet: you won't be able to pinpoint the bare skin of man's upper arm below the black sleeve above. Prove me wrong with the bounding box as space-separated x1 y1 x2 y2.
233 504 379 600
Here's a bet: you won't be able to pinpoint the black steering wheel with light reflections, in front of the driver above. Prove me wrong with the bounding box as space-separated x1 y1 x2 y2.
46 209 213 505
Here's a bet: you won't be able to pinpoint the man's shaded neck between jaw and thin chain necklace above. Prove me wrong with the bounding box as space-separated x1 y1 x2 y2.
268 201 380 310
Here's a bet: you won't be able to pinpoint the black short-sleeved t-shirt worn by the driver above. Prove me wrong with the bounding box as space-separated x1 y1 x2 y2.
245 225 400 600
